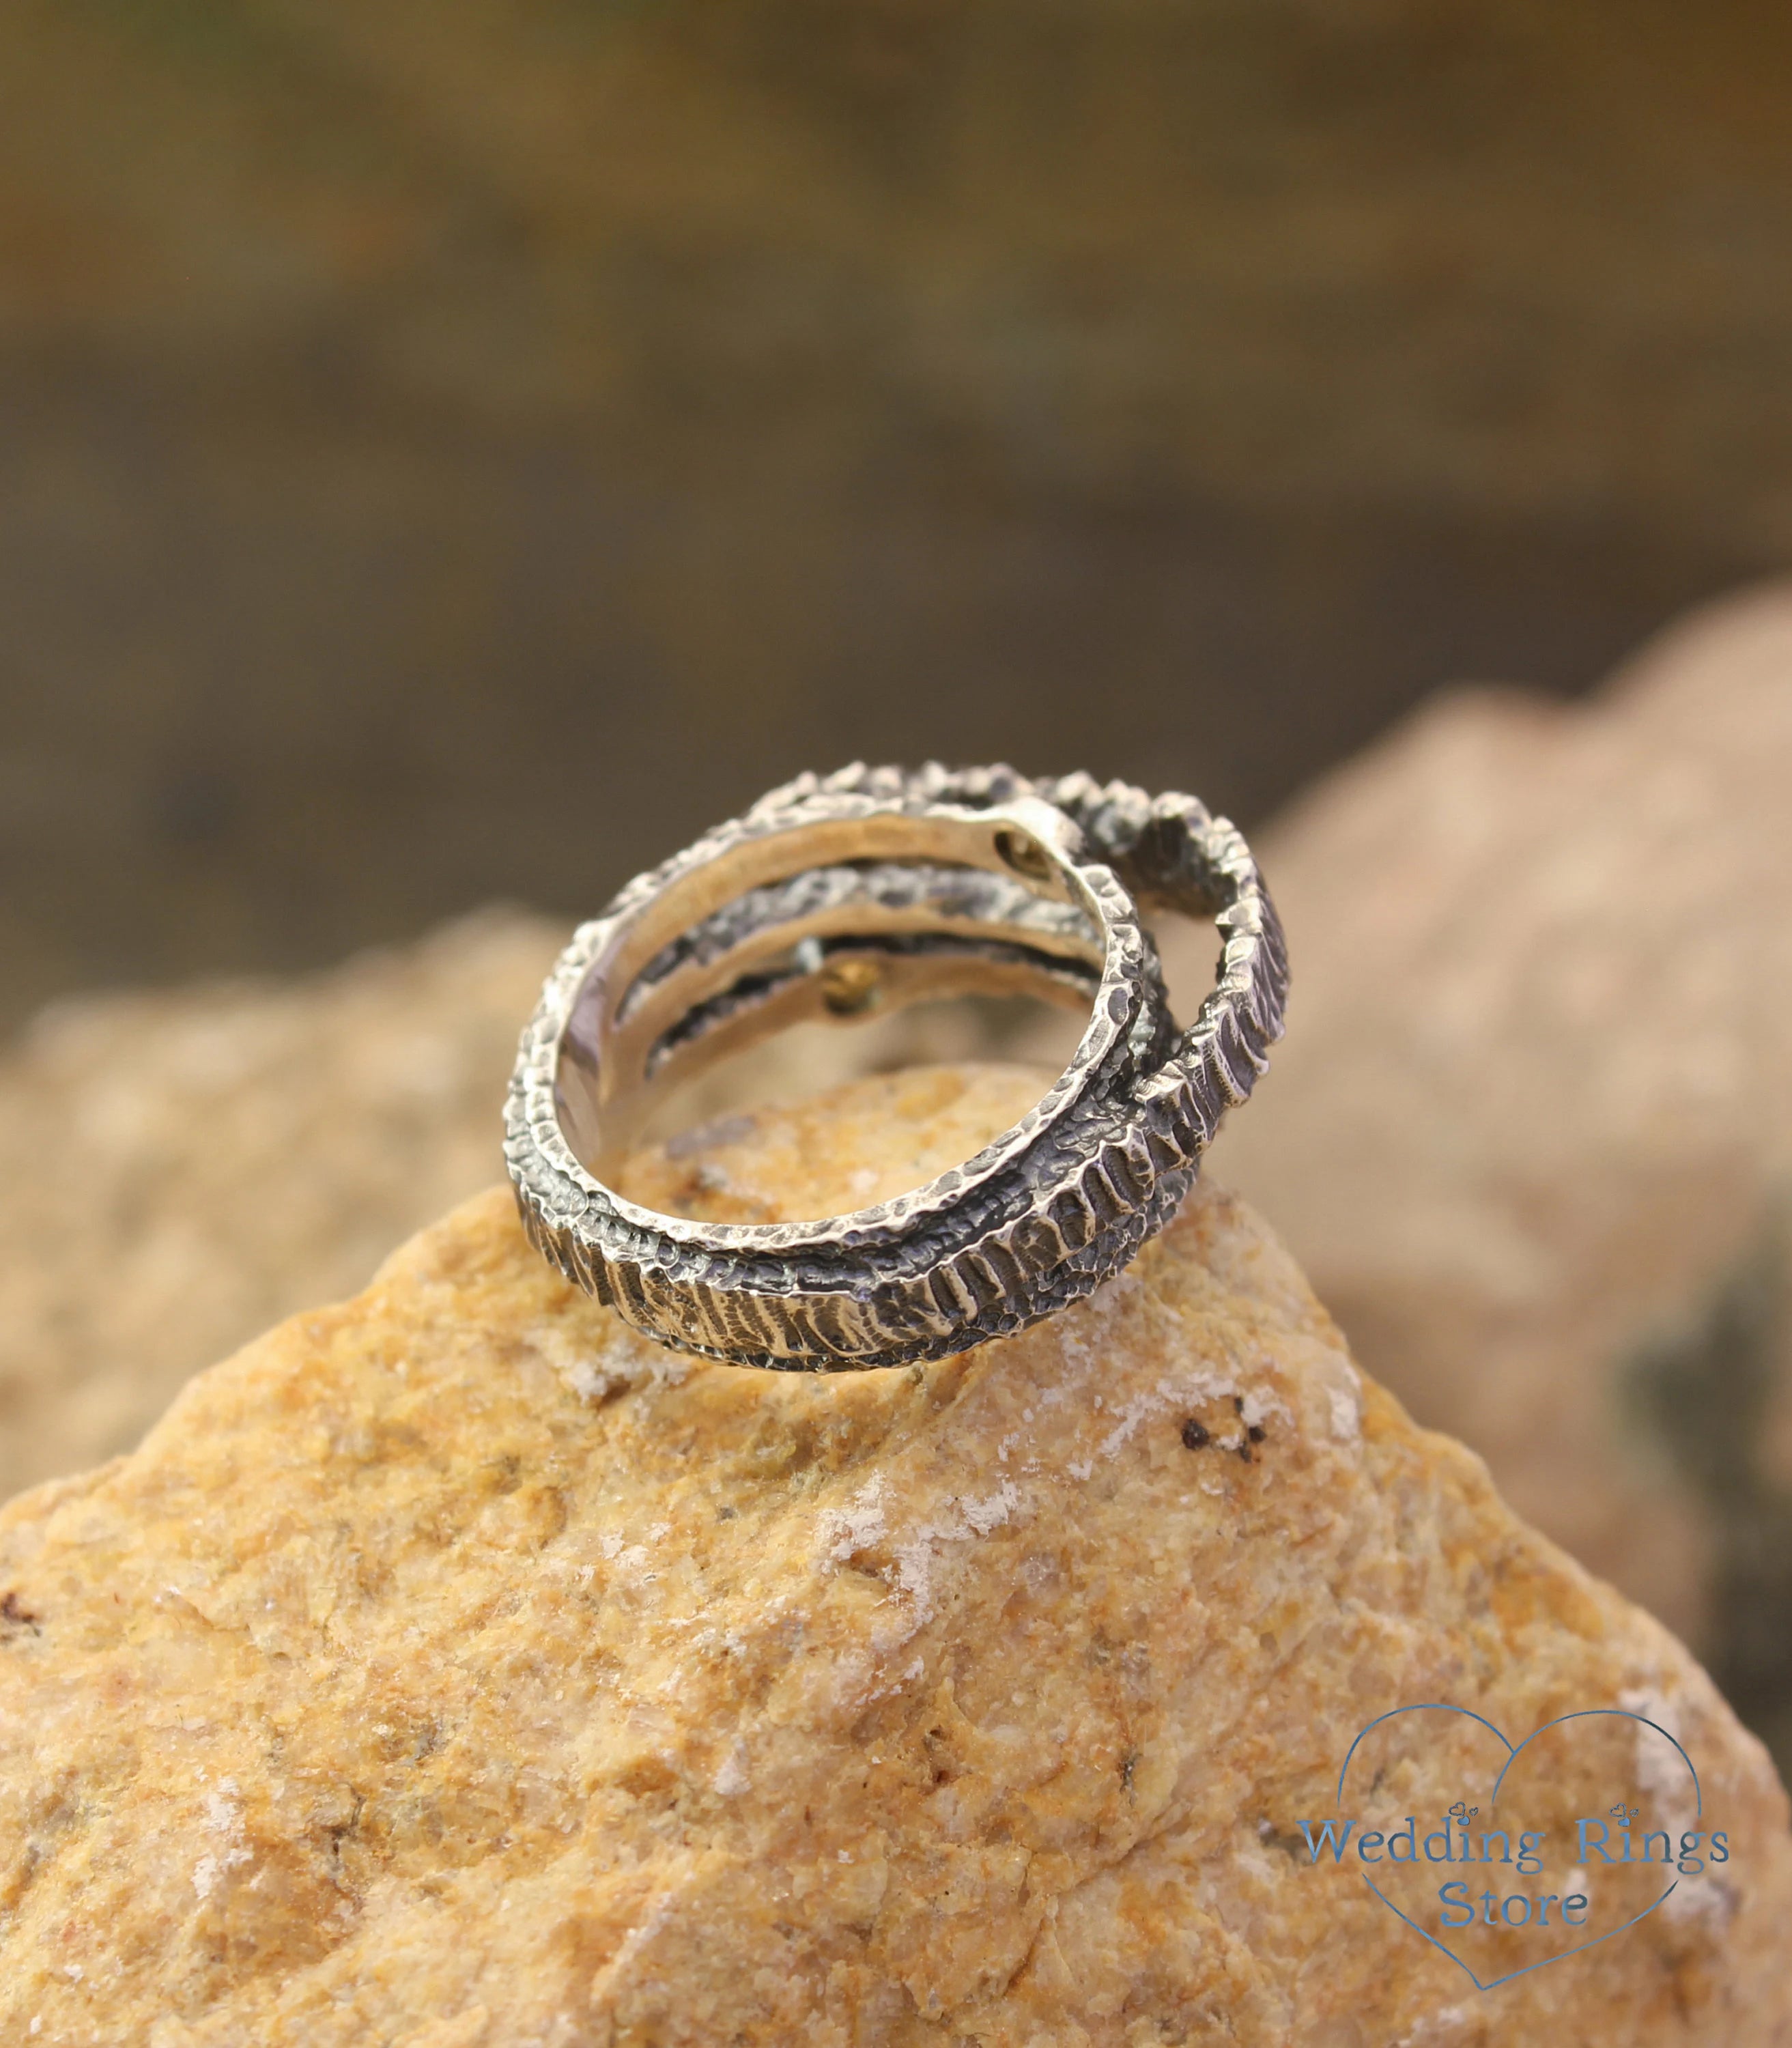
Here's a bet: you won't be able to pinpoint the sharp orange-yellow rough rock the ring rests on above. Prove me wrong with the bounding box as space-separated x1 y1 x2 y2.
0 1069 1792 2048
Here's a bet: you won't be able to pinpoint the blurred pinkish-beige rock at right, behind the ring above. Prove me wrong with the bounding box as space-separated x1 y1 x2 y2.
1198 588 1792 1763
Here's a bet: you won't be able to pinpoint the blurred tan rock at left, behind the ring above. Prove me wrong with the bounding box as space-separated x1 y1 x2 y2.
0 911 1036 1497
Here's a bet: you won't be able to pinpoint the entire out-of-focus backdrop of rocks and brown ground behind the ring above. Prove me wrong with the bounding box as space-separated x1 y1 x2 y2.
0 0 1792 1761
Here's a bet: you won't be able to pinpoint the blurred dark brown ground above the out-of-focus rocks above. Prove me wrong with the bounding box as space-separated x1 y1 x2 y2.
0 0 1792 1018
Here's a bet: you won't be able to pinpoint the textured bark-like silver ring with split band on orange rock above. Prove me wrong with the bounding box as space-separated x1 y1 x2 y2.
504 764 1288 1372
